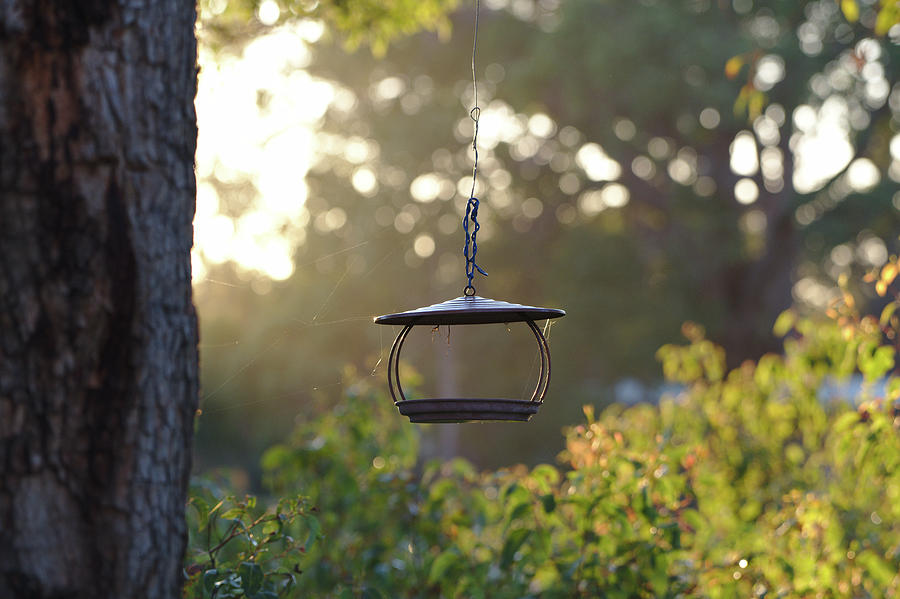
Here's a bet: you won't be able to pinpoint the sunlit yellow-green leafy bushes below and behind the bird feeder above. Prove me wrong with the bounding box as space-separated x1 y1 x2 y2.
186 284 900 599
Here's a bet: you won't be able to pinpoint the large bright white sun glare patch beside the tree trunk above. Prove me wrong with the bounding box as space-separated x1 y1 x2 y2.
192 22 335 281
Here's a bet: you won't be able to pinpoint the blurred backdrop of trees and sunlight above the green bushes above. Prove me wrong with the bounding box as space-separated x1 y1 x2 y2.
195 0 900 473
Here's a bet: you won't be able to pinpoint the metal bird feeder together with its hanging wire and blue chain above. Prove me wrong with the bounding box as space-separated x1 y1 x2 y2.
375 0 566 423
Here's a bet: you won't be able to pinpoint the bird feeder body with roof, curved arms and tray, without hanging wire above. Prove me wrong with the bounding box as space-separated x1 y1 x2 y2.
375 296 566 423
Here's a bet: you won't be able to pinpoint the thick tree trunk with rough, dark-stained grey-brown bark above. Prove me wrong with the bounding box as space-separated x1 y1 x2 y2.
0 0 198 598
